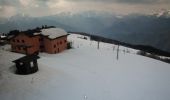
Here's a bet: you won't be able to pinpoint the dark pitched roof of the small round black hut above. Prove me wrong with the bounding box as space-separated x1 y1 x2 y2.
12 54 40 63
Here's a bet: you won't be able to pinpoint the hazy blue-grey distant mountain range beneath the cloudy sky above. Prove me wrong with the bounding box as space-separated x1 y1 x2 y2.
0 10 170 52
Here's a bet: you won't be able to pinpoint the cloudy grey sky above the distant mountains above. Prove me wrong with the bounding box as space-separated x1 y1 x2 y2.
0 0 170 18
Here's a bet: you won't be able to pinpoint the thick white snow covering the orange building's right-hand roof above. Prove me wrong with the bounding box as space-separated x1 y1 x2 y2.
41 28 67 39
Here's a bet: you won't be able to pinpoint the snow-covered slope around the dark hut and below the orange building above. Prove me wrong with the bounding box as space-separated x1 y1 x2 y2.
0 35 170 100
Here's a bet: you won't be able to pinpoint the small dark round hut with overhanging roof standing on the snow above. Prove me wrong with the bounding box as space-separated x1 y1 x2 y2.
13 55 40 75
